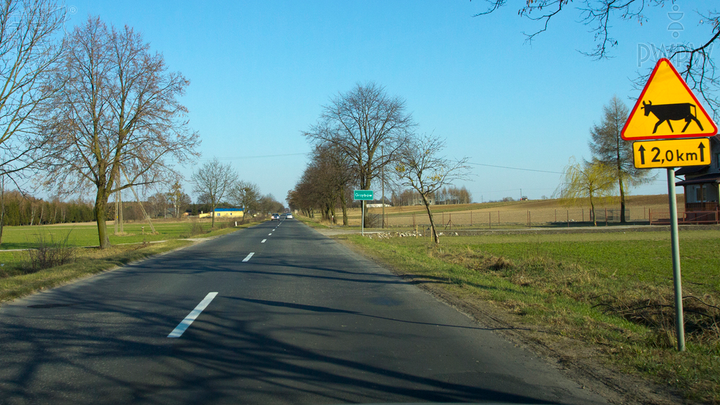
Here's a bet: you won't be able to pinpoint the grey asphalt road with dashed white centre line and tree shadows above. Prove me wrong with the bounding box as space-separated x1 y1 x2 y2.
0 220 605 404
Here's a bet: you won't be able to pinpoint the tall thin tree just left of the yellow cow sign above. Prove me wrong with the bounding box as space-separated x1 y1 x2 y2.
588 96 654 223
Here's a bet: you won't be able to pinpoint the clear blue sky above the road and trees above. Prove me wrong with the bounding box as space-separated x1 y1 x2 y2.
67 0 718 202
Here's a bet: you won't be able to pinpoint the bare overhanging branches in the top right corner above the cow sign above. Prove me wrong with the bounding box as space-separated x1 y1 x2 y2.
476 0 720 117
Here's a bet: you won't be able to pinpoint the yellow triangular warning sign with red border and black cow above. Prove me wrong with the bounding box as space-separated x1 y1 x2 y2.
621 58 717 141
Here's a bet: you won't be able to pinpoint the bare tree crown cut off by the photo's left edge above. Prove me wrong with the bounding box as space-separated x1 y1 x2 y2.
0 0 65 175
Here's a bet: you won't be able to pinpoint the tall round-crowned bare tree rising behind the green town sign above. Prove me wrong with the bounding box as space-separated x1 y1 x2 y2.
303 82 415 197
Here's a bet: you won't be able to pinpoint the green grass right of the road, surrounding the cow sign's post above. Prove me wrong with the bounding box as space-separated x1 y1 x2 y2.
346 231 720 403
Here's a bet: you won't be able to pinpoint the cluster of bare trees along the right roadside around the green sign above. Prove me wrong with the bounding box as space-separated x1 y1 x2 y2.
286 82 469 243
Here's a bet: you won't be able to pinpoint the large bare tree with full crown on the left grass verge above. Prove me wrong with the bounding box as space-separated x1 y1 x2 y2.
40 18 199 248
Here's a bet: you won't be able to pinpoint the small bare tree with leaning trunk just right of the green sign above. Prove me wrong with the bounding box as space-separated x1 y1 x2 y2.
394 135 470 244
